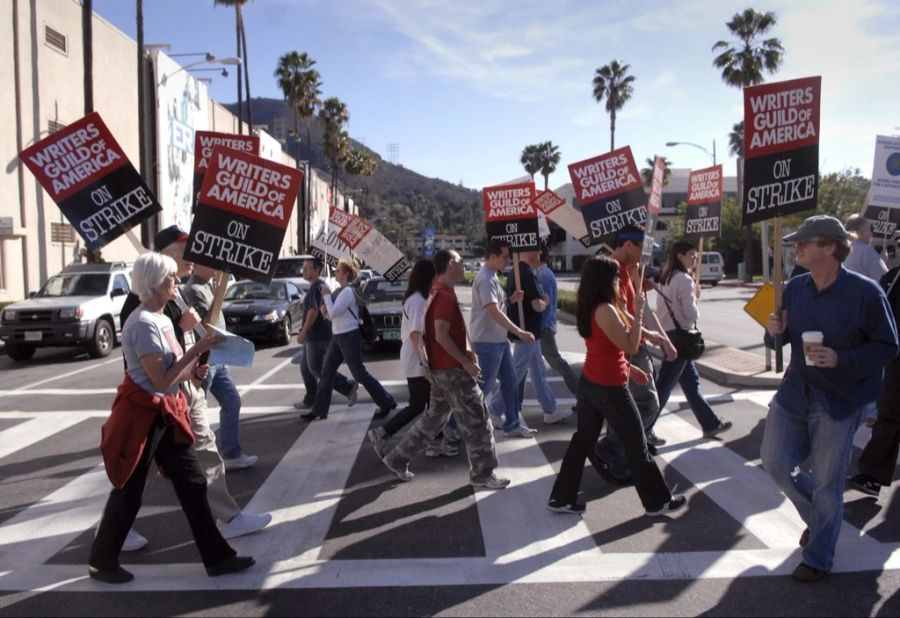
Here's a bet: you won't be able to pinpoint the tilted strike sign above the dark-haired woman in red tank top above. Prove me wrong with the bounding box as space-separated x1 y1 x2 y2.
569 146 647 245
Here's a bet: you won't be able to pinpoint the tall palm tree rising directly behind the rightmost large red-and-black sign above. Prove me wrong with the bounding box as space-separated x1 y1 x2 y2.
712 9 784 281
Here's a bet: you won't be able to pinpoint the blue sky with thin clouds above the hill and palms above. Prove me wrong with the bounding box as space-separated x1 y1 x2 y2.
94 0 900 188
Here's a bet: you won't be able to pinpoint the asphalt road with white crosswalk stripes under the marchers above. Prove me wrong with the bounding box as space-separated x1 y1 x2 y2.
0 290 900 616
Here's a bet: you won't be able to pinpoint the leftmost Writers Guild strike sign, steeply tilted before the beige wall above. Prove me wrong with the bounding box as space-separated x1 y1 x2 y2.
19 112 161 249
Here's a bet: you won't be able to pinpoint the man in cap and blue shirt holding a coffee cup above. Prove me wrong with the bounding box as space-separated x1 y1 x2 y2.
761 215 898 582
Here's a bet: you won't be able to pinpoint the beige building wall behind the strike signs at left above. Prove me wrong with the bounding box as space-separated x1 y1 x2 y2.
0 0 310 302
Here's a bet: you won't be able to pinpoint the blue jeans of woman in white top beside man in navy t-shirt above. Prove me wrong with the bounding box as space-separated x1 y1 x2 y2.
312 328 397 418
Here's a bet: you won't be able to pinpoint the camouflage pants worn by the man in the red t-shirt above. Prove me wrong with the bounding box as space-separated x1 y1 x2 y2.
385 368 498 481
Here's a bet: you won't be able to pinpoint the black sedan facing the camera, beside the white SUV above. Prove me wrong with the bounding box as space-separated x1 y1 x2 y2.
222 279 306 345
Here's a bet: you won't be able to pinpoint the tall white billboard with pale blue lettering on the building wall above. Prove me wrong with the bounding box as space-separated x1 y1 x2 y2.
151 51 209 230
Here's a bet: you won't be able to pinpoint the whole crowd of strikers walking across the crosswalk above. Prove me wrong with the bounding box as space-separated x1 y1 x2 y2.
89 216 900 583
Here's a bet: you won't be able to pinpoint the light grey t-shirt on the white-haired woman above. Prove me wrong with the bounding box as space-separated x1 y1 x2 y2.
122 305 184 396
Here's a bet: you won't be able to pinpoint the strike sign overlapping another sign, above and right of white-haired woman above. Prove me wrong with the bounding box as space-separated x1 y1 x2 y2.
184 146 302 283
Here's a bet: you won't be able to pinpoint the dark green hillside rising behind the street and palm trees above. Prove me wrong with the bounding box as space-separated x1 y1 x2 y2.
225 98 484 248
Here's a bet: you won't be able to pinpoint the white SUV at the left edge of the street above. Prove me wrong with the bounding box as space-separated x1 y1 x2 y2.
0 262 131 361
